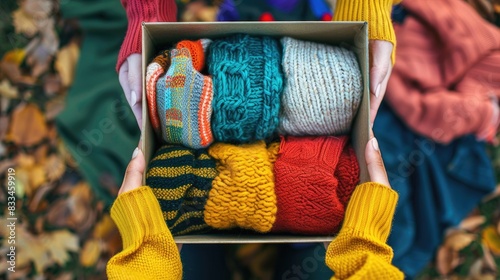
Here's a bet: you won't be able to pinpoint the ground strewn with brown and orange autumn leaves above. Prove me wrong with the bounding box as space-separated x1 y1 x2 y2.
0 0 500 279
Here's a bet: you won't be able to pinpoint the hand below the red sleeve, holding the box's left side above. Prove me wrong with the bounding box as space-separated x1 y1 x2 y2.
118 53 142 130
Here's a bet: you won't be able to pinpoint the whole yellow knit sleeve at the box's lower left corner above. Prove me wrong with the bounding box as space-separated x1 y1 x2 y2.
106 187 182 280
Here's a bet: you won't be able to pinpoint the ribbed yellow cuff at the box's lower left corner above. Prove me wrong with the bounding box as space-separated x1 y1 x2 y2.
111 186 173 248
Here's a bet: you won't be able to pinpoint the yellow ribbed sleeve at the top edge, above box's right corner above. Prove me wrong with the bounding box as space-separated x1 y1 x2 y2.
333 0 401 64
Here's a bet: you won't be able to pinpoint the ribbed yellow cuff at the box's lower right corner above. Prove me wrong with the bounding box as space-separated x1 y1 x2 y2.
342 182 398 242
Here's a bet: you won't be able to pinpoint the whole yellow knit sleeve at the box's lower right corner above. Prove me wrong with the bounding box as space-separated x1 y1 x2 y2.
326 183 404 279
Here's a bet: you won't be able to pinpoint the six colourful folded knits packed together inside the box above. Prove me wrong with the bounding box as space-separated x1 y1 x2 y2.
146 34 363 235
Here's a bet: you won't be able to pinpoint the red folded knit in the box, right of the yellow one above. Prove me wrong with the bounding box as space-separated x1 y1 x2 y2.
273 136 359 235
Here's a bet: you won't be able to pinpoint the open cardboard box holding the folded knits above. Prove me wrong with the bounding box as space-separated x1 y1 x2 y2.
141 22 370 244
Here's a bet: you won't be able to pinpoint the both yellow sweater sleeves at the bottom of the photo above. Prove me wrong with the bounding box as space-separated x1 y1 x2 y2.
107 183 404 279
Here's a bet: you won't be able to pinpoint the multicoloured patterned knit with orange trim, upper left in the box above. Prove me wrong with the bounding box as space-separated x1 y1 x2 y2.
156 48 213 149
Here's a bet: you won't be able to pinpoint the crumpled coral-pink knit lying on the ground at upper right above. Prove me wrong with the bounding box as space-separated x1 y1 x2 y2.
385 0 500 143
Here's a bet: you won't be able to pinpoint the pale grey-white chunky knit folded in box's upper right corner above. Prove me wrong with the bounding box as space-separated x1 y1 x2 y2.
279 37 363 136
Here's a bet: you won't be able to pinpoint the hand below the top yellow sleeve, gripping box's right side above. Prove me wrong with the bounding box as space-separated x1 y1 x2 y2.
370 40 393 125
